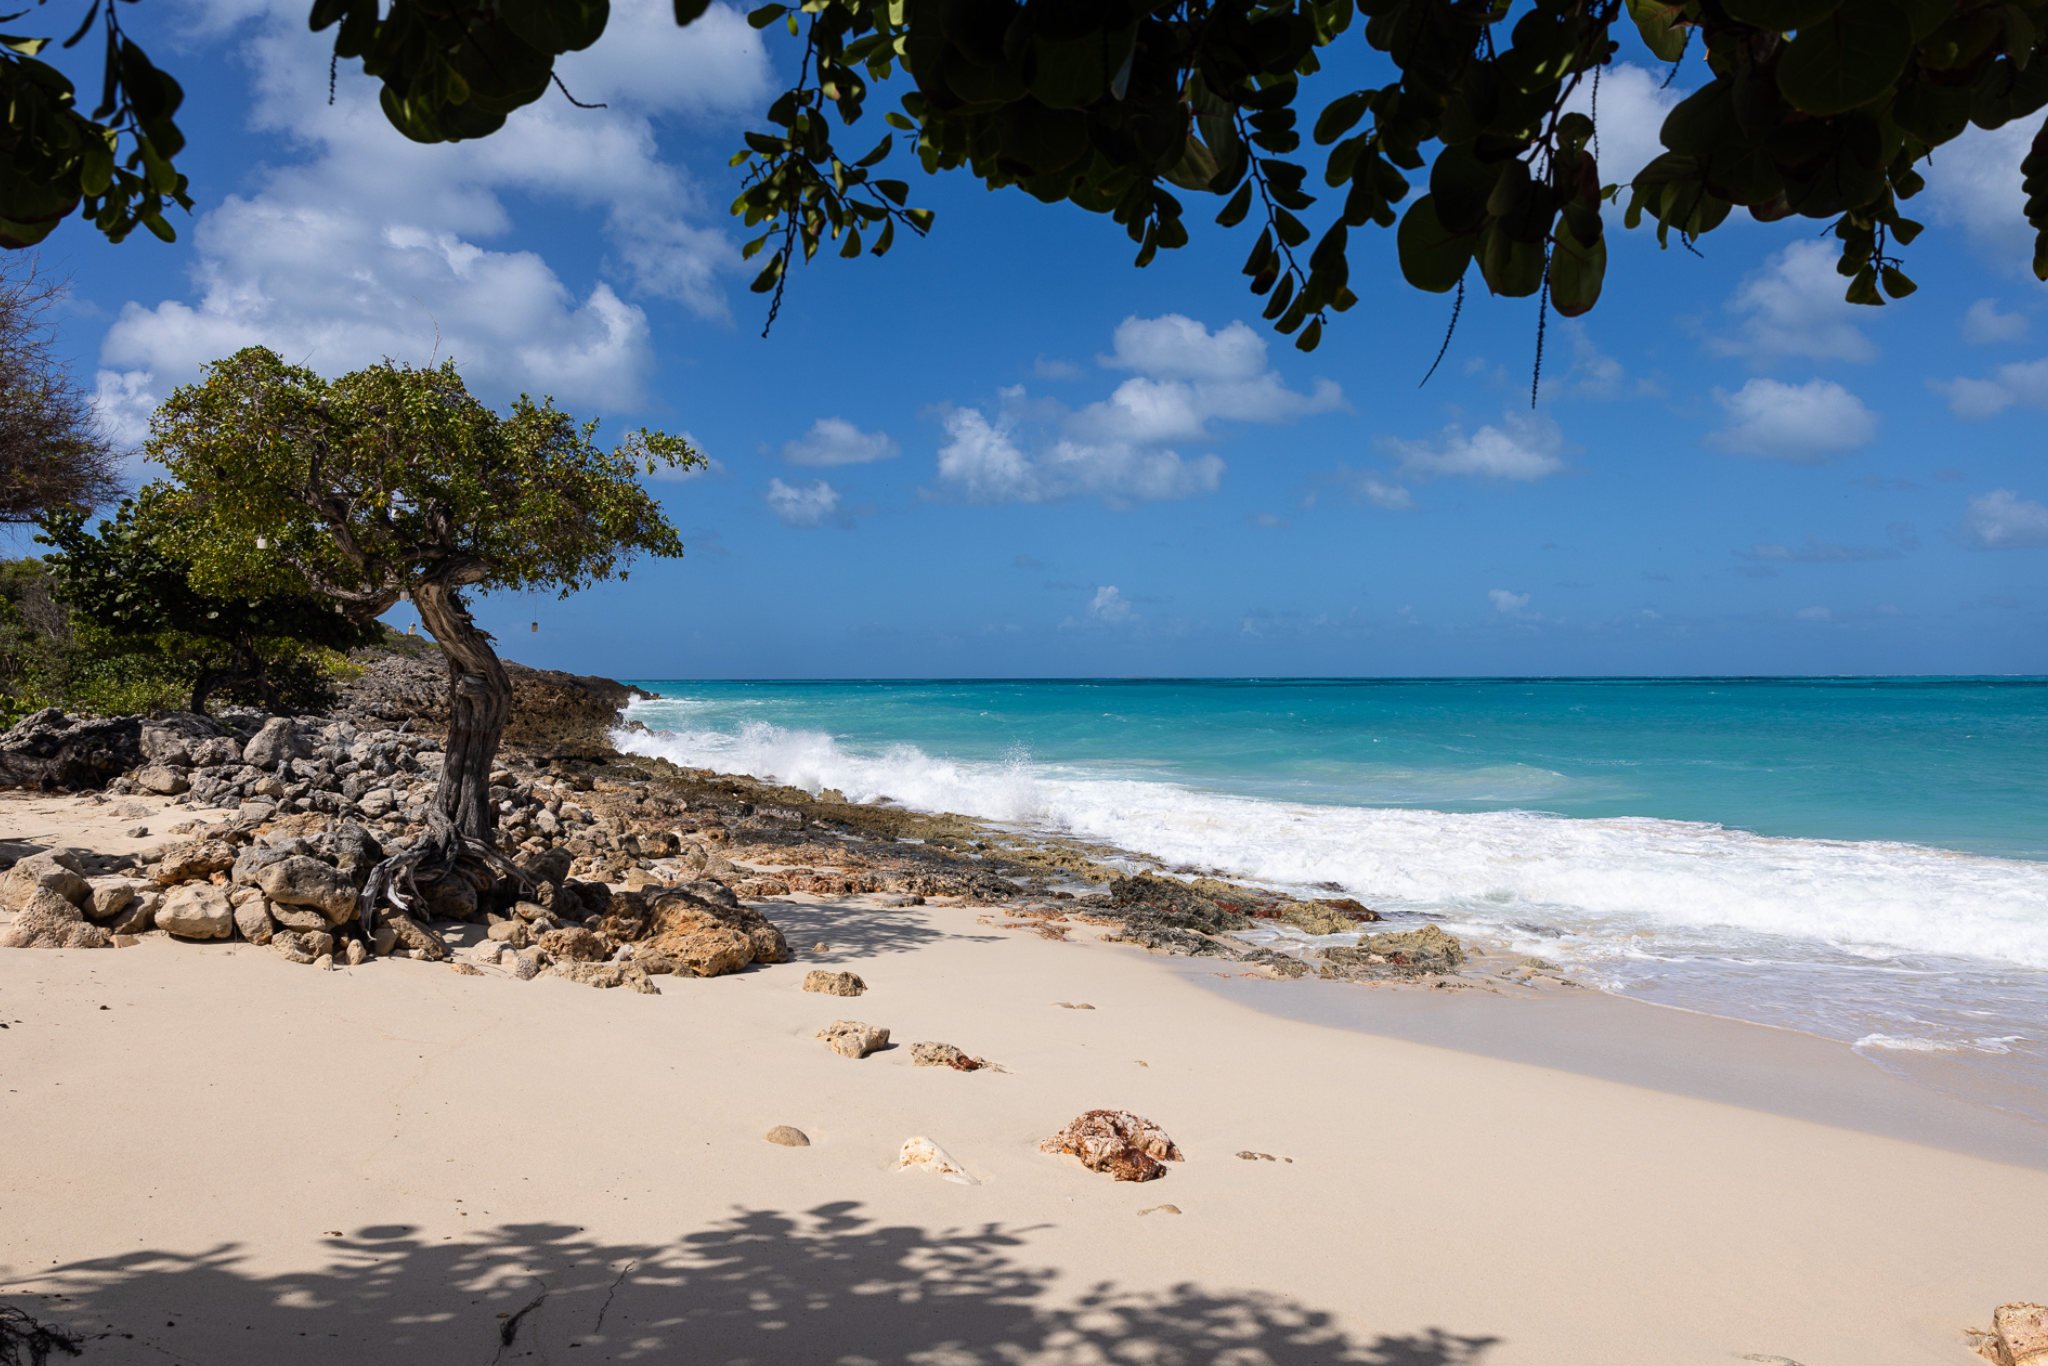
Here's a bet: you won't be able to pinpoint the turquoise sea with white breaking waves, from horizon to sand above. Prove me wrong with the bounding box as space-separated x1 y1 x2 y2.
621 678 2048 1096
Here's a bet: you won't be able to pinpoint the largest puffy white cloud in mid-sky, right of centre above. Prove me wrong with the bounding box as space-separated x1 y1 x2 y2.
938 313 1343 504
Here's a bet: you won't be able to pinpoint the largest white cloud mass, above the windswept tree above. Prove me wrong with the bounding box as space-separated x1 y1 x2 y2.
102 0 770 417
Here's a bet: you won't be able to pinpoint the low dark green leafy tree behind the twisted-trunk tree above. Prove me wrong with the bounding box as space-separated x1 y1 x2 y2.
39 485 381 713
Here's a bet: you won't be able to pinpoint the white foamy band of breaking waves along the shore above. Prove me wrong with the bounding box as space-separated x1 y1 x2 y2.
616 702 2048 971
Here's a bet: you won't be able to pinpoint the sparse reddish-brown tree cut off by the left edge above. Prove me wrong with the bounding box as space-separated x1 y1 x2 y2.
0 264 121 526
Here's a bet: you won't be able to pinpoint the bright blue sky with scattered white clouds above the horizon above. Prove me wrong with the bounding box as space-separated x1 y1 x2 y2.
28 0 2048 678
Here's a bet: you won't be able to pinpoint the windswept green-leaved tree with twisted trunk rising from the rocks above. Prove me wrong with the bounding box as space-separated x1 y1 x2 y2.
147 346 702 858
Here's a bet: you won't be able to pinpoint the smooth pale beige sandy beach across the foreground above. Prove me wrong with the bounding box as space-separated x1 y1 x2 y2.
0 799 2048 1366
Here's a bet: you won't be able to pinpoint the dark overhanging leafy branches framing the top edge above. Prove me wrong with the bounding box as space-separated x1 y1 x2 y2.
12 0 2048 348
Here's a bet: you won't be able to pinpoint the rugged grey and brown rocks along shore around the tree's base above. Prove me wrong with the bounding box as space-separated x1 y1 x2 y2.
0 641 1563 991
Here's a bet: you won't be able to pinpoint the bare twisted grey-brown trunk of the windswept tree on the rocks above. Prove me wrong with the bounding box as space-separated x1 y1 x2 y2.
412 567 512 848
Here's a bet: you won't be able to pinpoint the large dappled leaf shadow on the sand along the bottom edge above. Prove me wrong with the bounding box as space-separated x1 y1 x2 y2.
0 1204 1497 1366
